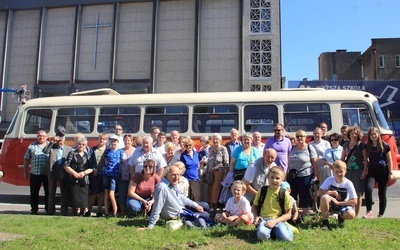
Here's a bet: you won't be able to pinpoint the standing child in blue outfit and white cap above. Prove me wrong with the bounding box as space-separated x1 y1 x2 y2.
103 135 123 216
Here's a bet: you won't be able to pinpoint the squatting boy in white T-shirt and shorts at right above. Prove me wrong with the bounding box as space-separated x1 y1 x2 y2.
318 160 357 230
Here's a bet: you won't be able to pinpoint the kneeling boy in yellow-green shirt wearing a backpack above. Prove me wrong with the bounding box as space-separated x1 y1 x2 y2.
252 167 293 241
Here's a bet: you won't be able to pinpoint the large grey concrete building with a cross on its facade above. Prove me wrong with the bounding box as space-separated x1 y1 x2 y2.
0 0 281 129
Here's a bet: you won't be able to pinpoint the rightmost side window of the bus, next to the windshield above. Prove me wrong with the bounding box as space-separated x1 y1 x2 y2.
342 103 376 131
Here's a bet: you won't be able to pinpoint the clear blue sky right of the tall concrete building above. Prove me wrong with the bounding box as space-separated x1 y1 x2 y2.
280 0 400 83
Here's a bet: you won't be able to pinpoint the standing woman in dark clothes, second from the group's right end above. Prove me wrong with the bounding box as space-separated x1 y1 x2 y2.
341 126 368 217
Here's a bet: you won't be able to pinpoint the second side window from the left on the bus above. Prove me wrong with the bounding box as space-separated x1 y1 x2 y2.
54 108 95 134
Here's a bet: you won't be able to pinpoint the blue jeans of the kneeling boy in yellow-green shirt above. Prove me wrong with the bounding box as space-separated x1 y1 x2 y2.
257 218 293 241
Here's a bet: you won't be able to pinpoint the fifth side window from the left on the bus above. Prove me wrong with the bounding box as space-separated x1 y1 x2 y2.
192 105 238 133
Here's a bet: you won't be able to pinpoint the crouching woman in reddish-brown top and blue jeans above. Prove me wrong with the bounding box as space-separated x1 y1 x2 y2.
126 159 160 214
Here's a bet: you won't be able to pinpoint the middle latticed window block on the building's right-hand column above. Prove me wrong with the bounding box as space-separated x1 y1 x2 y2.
250 39 272 79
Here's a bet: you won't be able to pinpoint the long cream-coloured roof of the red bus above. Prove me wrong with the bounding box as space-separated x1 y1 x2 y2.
21 89 377 109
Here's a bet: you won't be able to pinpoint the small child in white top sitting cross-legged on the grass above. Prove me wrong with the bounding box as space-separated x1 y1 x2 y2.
215 181 253 227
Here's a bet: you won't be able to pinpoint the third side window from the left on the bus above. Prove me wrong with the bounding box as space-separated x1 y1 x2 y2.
97 106 140 133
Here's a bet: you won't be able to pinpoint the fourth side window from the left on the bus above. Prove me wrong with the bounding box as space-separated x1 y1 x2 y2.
143 106 189 133
